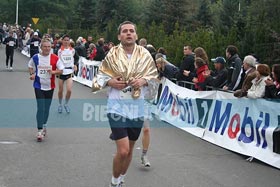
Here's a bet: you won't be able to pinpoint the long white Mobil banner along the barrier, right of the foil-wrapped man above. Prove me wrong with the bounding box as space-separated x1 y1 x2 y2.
156 80 280 168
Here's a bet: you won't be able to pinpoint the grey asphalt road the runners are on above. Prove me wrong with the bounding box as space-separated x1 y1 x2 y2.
0 46 280 187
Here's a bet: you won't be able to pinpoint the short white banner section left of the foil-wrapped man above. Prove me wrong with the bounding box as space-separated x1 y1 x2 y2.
73 57 101 87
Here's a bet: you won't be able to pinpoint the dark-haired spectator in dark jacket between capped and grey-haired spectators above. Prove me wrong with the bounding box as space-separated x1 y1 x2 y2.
223 45 242 91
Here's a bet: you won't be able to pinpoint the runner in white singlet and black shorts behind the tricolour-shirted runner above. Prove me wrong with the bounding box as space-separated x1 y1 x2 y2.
58 35 77 113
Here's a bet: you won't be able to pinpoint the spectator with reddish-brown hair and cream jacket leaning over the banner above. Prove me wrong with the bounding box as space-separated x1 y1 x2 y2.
245 64 270 99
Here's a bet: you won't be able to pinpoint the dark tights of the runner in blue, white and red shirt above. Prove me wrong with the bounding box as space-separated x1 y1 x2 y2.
35 88 54 129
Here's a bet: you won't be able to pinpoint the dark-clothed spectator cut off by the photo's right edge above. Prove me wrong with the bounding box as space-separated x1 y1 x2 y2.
264 64 280 99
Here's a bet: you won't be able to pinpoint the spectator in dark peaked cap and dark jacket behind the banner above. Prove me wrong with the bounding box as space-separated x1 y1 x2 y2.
203 57 228 88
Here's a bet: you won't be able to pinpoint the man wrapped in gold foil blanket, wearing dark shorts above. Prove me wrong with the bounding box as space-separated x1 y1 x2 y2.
97 21 158 187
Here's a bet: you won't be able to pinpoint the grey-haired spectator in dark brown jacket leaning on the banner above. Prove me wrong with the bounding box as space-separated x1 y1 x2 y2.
234 55 257 97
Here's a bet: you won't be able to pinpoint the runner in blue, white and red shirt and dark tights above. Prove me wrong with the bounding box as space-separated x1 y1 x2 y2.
28 39 64 141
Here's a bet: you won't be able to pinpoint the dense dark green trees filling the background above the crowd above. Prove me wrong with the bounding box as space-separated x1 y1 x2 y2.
0 0 280 64
